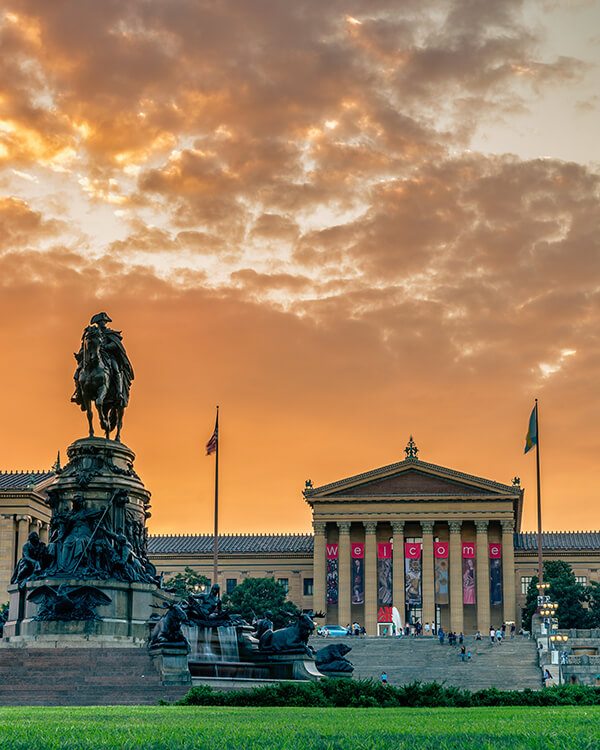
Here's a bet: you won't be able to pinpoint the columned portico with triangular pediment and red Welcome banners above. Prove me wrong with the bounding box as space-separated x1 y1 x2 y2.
304 439 523 635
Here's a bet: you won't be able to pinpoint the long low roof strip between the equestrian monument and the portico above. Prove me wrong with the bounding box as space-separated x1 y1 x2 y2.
148 534 313 555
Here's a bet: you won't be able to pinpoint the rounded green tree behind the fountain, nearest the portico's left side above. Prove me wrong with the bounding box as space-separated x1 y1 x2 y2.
223 578 300 628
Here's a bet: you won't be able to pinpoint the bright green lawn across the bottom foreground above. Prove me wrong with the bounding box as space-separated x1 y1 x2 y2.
0 706 600 750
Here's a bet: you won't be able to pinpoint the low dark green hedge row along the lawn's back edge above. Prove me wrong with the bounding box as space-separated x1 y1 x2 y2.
176 679 600 708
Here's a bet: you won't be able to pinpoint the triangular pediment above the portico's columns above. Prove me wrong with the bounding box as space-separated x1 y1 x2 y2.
304 460 520 502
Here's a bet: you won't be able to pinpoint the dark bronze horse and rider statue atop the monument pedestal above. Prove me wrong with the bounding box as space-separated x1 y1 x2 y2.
71 312 133 441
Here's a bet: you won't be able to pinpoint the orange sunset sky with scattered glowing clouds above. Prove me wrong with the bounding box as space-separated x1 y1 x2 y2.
0 0 600 533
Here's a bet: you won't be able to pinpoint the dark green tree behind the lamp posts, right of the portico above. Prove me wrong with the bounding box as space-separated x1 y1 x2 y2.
524 560 589 628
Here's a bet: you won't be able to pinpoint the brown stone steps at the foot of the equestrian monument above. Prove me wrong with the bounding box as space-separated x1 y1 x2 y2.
0 648 189 706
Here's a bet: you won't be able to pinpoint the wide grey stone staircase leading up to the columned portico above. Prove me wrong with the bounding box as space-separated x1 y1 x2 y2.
310 636 542 690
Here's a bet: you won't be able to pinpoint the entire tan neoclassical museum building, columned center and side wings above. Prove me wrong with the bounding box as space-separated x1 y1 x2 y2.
0 438 600 634
